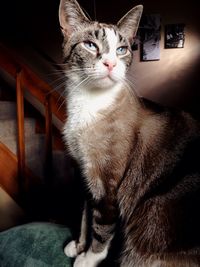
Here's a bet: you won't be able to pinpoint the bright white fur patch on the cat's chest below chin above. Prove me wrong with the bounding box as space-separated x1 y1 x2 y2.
64 83 123 159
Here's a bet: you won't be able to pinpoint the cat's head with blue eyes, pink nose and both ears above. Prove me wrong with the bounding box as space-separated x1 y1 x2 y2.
59 0 143 89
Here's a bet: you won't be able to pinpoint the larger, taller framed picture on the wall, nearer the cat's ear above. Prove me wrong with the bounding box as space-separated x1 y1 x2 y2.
140 14 161 61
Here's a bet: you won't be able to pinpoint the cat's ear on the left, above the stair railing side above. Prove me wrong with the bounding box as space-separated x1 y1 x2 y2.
59 0 90 39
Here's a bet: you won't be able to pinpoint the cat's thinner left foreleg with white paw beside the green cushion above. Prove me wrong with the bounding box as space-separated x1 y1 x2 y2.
64 201 88 258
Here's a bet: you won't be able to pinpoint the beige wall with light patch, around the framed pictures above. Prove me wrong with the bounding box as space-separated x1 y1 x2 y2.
132 0 200 111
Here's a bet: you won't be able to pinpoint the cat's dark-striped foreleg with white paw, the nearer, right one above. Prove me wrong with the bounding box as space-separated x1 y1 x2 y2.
74 200 116 267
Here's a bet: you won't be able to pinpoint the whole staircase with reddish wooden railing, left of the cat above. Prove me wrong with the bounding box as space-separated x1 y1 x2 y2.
0 44 82 230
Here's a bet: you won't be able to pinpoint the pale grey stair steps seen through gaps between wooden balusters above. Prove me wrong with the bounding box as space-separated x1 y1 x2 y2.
0 101 66 180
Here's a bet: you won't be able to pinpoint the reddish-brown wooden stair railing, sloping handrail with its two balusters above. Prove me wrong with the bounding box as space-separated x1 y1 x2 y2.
0 44 66 195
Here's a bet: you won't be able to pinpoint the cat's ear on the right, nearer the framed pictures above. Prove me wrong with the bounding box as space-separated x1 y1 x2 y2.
117 5 143 42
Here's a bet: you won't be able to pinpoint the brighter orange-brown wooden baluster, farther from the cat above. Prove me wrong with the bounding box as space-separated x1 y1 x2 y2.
16 71 25 191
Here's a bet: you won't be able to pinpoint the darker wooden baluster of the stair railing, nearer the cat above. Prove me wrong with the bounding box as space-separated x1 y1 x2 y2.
45 94 53 185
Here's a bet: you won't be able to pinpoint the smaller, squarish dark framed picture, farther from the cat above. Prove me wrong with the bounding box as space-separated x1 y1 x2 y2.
165 23 185 48
